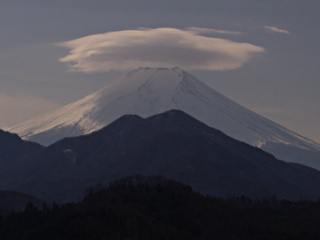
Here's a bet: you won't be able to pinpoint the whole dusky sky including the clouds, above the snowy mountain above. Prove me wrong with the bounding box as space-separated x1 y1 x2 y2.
0 0 320 142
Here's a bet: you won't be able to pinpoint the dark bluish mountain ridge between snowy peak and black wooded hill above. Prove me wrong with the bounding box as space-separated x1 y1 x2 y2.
0 110 320 202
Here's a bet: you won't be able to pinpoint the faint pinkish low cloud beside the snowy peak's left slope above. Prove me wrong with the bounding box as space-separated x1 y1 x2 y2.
0 93 59 129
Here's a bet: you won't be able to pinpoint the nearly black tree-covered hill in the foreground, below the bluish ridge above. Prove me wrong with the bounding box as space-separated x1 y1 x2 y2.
0 176 320 240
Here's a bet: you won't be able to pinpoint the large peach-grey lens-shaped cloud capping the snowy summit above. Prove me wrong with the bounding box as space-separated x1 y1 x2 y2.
58 28 264 73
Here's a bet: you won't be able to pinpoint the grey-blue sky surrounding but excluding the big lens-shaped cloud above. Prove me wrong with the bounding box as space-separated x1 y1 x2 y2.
0 0 320 141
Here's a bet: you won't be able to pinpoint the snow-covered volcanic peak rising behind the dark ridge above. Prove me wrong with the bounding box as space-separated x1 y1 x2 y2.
7 67 320 169
